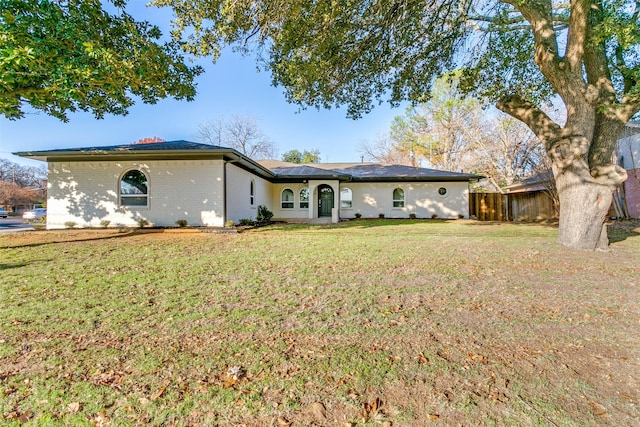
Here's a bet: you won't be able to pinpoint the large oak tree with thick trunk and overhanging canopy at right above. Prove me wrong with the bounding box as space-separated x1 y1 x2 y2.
155 0 640 250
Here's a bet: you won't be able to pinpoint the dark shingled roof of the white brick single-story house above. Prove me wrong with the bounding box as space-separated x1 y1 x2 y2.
14 141 482 182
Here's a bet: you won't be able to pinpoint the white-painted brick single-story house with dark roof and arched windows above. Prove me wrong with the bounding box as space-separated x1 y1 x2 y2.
15 141 480 229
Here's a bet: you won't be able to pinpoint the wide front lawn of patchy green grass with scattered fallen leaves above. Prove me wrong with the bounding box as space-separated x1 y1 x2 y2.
0 220 640 426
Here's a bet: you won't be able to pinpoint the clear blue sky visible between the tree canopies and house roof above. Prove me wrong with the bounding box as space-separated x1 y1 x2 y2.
0 0 403 165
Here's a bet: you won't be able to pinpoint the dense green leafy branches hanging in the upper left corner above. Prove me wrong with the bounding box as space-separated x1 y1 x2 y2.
0 0 202 121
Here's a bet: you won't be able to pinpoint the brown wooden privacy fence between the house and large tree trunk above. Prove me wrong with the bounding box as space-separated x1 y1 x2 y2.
469 191 555 221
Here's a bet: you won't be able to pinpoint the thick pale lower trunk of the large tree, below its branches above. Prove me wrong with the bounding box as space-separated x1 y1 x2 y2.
553 166 613 250
